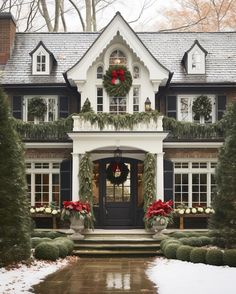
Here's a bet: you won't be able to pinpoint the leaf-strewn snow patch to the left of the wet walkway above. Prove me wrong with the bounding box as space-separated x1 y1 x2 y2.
0 258 70 294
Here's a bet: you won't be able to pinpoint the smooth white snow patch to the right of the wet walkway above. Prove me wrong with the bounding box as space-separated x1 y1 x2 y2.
146 258 236 294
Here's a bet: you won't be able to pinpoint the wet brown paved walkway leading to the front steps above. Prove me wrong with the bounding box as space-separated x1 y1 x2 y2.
33 257 157 294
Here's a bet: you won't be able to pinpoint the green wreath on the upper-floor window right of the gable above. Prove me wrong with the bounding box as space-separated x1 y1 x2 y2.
192 96 212 120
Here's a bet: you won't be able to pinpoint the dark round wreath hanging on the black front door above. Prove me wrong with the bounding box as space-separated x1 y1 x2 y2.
106 162 129 185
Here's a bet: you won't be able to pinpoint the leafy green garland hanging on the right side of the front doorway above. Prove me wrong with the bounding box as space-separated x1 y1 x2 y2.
143 153 156 211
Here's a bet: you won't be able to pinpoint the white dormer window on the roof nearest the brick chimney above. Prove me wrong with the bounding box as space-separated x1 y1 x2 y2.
30 41 56 75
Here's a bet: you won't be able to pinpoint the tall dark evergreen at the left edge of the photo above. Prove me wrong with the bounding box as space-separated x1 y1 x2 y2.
0 88 31 265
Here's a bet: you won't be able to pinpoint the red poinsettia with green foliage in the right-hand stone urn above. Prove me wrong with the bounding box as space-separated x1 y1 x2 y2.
144 200 173 223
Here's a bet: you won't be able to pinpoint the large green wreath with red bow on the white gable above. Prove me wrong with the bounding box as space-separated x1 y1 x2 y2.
103 65 132 97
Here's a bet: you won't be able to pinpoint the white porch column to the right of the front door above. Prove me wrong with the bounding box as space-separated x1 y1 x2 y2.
156 152 164 200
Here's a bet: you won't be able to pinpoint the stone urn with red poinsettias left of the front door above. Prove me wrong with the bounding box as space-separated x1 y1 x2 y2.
61 201 93 240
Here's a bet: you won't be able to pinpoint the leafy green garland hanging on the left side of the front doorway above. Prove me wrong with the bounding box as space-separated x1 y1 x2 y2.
79 152 94 228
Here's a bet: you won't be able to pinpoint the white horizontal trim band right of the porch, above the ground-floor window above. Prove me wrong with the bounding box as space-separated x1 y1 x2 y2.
163 142 224 149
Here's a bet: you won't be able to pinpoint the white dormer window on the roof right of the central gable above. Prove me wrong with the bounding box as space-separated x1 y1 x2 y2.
182 40 207 74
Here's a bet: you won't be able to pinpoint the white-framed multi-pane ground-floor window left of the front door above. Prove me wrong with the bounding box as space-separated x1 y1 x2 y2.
26 162 60 206
